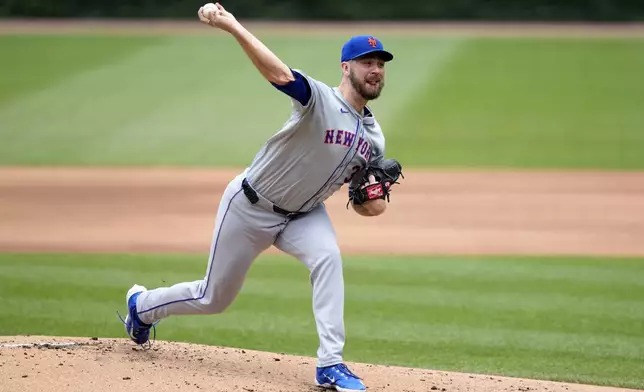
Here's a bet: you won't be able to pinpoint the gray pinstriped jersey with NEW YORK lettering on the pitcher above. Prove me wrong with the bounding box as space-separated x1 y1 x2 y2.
248 70 385 211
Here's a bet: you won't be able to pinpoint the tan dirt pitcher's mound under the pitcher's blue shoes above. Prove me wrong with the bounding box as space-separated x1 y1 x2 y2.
0 336 636 392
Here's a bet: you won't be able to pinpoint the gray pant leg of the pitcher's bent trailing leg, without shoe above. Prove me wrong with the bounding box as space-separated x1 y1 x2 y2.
136 175 284 324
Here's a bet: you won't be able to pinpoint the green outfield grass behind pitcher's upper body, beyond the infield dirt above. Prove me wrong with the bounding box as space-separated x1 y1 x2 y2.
0 34 644 169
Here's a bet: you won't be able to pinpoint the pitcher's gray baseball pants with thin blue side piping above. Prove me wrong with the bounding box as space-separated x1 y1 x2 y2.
137 171 345 367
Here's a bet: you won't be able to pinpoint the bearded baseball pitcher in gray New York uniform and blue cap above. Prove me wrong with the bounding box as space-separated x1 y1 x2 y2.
117 3 402 391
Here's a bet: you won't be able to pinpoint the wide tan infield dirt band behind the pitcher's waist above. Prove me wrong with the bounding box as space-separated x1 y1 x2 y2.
0 168 644 256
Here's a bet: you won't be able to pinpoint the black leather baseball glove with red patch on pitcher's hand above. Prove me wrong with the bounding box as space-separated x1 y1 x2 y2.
347 159 405 208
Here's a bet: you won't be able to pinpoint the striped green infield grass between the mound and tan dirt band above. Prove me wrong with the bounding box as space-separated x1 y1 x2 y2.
0 254 644 388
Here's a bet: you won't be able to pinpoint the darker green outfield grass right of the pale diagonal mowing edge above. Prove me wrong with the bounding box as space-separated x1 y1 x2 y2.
388 38 644 169
